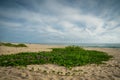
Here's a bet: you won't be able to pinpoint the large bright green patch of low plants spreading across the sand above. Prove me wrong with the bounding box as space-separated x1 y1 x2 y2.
0 46 112 67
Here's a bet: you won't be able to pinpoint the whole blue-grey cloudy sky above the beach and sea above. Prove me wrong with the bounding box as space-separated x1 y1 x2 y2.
0 0 120 43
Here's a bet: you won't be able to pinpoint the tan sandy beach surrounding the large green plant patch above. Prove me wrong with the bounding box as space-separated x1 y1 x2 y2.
0 44 120 80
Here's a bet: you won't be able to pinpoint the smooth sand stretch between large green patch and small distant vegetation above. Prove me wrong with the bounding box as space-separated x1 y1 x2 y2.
0 44 64 55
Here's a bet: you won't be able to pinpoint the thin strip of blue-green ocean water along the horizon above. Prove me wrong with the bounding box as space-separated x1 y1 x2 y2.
40 43 120 48
